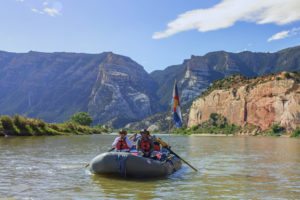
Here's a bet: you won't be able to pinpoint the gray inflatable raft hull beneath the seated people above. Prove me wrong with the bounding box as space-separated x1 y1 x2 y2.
90 152 181 178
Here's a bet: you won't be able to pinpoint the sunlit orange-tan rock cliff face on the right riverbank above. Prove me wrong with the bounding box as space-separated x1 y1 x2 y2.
188 72 300 131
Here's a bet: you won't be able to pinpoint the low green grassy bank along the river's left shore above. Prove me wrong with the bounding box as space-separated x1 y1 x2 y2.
0 114 104 136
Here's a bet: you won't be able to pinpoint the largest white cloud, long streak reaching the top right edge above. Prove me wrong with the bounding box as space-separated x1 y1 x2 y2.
152 0 300 39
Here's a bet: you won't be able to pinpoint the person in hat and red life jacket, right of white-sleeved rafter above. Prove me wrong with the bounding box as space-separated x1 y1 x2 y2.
136 129 154 157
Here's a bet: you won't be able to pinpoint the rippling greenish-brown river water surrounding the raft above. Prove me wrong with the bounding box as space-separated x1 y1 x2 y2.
0 135 300 200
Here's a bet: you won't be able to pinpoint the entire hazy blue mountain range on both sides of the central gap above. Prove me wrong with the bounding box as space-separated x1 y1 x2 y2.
0 46 300 127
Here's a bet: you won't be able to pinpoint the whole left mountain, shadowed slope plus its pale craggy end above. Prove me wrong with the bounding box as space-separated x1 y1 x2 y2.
0 51 160 123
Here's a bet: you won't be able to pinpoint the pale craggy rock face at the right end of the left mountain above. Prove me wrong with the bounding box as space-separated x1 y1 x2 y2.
88 54 161 123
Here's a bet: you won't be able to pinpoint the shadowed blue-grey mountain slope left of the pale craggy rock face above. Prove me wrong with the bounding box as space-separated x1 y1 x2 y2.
0 52 105 122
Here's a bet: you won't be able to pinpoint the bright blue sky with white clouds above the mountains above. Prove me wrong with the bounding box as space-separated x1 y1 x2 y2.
0 0 300 72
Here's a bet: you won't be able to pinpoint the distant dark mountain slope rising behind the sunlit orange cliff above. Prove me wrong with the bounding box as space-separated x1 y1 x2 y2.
151 46 300 109
